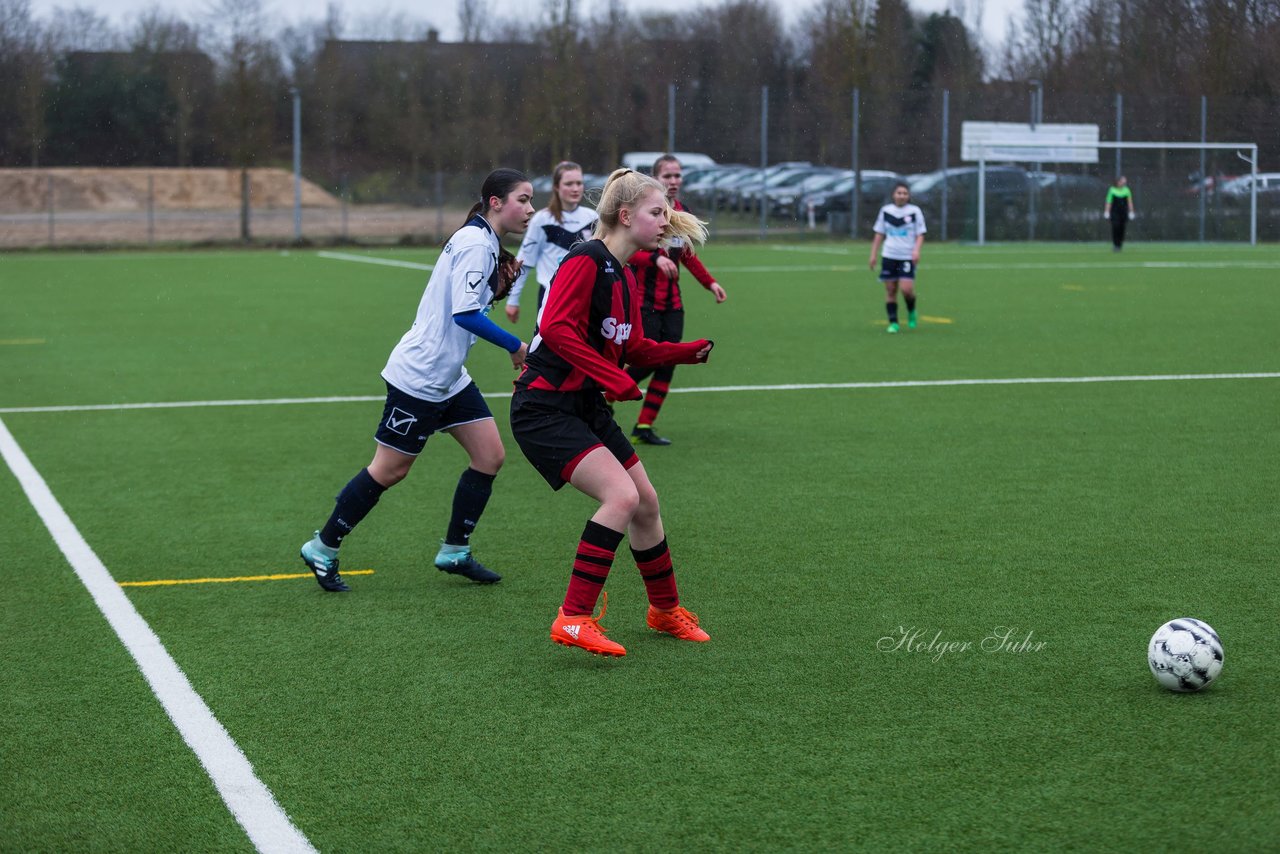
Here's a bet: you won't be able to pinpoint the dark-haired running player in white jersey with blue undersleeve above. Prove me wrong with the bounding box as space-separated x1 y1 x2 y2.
302 169 534 593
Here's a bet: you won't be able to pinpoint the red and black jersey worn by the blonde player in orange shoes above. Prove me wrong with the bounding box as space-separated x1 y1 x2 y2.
516 239 708 401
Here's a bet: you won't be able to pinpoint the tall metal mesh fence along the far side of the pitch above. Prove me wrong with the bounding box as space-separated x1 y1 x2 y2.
0 87 1280 248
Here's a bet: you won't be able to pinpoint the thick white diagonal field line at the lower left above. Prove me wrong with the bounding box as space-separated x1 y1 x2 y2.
0 421 315 854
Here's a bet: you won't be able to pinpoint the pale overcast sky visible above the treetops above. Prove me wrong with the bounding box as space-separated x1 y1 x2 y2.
31 0 1023 47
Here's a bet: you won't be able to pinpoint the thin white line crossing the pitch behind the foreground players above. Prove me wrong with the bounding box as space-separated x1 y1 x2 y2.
0 371 1280 415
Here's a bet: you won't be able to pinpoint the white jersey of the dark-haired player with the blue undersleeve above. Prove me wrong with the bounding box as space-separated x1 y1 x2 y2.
383 214 499 402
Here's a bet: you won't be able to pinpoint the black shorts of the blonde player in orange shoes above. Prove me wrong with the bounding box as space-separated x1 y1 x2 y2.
511 388 640 489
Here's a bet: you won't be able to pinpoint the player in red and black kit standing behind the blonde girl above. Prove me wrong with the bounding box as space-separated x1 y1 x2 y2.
627 155 726 444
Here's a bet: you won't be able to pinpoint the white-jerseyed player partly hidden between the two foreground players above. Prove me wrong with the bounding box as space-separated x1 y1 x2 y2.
507 160 599 323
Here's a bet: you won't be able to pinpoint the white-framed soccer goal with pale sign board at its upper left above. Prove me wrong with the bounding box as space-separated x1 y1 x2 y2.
961 122 1260 245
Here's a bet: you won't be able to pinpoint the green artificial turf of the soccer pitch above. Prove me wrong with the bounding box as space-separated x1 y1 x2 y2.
0 243 1280 851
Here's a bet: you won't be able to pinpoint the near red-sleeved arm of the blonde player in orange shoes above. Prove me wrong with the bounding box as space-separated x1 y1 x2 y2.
539 255 641 401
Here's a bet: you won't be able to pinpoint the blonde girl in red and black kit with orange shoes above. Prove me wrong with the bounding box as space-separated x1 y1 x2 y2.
511 169 712 656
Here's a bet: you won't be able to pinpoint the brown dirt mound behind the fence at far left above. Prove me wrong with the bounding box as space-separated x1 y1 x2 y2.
0 169 340 214
